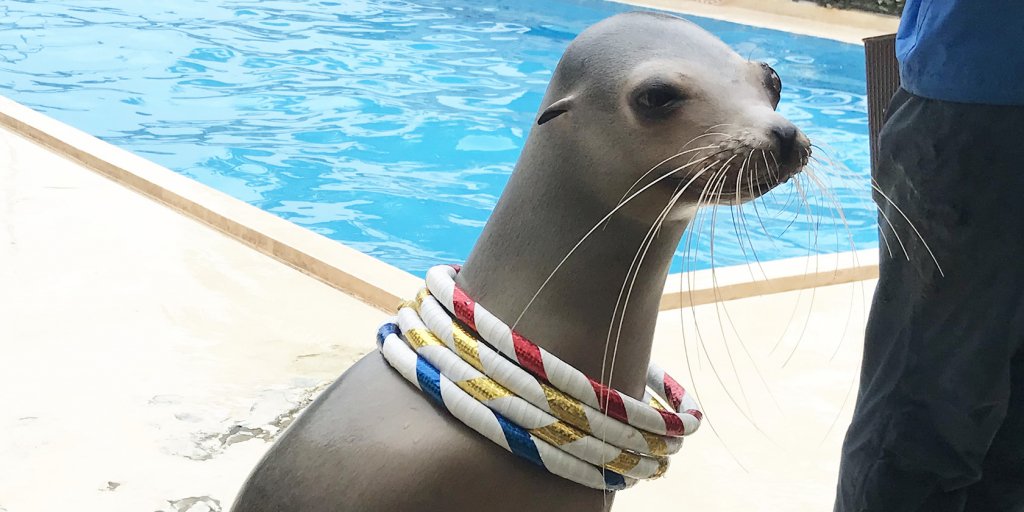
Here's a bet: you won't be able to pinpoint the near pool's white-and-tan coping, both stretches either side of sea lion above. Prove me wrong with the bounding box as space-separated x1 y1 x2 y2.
0 96 878 311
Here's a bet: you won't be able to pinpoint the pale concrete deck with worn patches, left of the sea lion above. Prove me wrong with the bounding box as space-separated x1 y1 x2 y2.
0 124 385 512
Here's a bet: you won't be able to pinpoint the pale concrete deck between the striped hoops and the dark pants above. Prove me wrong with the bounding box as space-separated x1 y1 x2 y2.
615 281 874 512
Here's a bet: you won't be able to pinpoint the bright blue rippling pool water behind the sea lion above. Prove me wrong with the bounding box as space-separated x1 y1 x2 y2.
0 0 878 273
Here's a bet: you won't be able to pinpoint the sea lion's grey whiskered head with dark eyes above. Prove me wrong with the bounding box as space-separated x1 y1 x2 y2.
534 12 811 211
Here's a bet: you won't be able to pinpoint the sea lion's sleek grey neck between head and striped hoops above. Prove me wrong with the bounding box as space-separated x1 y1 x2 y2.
458 142 688 397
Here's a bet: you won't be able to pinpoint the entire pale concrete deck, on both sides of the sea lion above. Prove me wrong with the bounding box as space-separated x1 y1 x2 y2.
0 124 871 512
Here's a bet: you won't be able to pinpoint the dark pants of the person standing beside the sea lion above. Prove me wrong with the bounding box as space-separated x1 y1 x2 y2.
836 90 1024 512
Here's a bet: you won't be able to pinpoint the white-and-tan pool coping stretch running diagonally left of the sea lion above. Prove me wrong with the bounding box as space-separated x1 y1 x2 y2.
0 96 422 311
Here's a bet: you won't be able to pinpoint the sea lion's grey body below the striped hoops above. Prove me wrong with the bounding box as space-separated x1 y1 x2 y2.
234 356 612 512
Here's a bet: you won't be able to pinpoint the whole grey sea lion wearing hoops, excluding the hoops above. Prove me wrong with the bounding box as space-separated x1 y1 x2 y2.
233 12 810 512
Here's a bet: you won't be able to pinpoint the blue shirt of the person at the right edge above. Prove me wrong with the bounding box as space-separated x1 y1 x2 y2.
896 0 1024 104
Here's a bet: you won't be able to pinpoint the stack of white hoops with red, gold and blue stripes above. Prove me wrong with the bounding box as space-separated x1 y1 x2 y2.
377 265 702 490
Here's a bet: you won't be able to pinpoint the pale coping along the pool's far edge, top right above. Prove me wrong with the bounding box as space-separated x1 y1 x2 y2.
612 0 899 45
